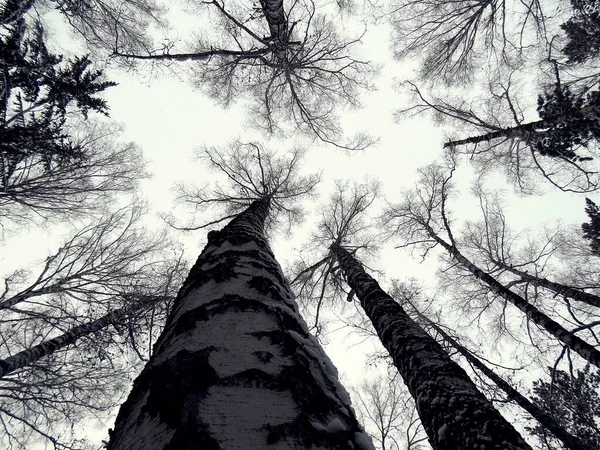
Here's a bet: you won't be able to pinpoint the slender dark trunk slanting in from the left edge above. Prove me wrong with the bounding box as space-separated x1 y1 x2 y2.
0 308 135 378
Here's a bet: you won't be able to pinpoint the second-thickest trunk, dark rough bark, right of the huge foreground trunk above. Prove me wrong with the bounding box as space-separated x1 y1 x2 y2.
331 245 531 450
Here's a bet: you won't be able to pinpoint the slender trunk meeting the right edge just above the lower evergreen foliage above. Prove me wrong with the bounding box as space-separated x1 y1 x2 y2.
423 224 600 367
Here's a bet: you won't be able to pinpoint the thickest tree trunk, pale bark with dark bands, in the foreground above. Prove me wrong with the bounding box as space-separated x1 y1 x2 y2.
109 198 373 450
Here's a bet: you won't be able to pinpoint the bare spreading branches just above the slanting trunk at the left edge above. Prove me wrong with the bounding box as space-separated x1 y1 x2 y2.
0 204 176 311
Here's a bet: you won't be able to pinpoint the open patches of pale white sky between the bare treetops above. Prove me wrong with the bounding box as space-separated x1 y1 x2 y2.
0 1 593 448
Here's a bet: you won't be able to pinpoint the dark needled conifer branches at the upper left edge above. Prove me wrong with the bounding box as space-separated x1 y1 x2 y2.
0 19 116 163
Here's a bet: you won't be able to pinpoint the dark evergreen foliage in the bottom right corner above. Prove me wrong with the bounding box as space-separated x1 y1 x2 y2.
530 365 600 448
